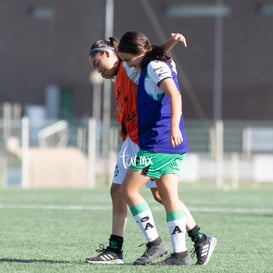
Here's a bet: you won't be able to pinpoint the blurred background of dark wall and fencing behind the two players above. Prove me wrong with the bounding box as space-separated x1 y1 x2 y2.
0 0 273 187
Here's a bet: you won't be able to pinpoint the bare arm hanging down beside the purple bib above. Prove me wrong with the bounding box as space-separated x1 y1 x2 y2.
159 78 183 147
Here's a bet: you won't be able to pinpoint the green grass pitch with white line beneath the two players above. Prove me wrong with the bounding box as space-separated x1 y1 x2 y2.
0 183 273 273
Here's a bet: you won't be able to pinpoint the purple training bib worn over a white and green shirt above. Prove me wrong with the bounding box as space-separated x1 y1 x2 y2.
137 62 189 154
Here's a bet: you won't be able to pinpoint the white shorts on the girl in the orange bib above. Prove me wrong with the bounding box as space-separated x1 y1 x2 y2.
112 136 156 188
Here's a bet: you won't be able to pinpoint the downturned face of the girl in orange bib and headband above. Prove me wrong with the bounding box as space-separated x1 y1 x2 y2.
89 50 119 79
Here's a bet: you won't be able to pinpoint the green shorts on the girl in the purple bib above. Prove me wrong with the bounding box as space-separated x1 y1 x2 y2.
130 150 186 178
